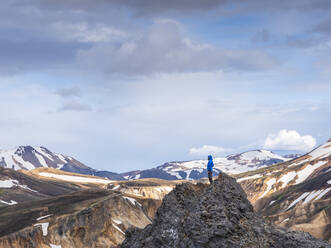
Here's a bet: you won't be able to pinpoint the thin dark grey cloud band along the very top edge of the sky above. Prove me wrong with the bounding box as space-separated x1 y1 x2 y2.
22 0 331 16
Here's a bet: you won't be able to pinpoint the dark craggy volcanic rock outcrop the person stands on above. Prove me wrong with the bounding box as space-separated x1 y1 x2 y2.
122 175 331 248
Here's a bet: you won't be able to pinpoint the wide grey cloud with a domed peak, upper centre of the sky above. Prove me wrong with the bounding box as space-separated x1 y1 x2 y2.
78 21 279 75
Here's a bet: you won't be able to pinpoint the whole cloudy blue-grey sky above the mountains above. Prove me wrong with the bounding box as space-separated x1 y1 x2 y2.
0 0 331 172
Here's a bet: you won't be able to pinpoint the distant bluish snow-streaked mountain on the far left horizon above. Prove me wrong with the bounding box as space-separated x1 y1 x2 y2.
0 146 124 180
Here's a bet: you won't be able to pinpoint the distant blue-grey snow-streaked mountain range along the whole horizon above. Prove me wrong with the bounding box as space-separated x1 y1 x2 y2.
0 146 298 180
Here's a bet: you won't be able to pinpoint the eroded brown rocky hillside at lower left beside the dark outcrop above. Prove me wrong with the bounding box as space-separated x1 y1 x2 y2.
0 189 155 248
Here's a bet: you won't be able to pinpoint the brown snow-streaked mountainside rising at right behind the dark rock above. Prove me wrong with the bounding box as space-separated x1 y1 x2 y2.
237 139 331 242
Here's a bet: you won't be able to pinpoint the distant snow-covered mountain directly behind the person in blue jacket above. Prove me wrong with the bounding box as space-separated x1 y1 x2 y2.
122 150 290 180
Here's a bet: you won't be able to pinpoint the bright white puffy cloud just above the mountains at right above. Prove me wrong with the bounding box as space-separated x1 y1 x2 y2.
263 129 316 151
